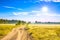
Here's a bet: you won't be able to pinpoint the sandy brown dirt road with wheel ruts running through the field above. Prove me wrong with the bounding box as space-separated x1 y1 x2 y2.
1 27 32 40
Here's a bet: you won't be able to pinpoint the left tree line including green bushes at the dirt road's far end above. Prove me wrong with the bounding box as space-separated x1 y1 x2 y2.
0 19 31 25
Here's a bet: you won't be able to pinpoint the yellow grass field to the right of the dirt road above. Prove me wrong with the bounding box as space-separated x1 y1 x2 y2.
28 24 60 40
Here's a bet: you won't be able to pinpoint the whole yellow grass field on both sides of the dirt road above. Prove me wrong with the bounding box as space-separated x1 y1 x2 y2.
0 24 60 40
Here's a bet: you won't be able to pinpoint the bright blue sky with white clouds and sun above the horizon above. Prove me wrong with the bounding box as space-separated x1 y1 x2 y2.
0 0 60 22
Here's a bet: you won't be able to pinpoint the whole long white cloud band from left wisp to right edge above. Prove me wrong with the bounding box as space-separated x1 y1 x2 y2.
13 11 60 17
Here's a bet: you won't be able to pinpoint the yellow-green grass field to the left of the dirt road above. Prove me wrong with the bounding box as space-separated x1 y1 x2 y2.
0 24 15 38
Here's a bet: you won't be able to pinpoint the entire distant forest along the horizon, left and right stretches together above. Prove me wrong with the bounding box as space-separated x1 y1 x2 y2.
0 19 60 24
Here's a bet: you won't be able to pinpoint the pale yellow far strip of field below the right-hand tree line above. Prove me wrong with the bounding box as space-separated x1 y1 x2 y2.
29 24 60 28
